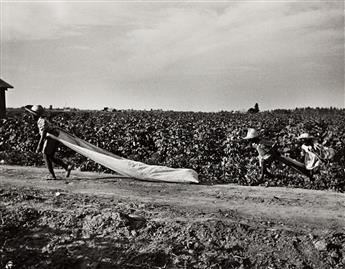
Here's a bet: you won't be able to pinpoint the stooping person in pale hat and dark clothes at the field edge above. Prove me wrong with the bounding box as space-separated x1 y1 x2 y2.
244 128 279 183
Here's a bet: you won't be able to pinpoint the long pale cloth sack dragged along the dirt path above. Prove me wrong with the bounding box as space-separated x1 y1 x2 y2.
48 129 199 183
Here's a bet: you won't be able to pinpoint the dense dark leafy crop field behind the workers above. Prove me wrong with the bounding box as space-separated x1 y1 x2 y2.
0 108 345 192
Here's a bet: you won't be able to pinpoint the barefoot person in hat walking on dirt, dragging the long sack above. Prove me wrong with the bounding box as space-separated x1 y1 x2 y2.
25 105 73 180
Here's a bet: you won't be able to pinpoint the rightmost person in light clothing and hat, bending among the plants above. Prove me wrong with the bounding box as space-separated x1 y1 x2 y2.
297 133 335 174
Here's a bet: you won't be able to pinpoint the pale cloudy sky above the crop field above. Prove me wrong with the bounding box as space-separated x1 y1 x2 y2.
0 0 345 111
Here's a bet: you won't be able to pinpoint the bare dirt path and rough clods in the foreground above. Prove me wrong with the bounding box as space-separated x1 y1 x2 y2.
0 165 345 269
